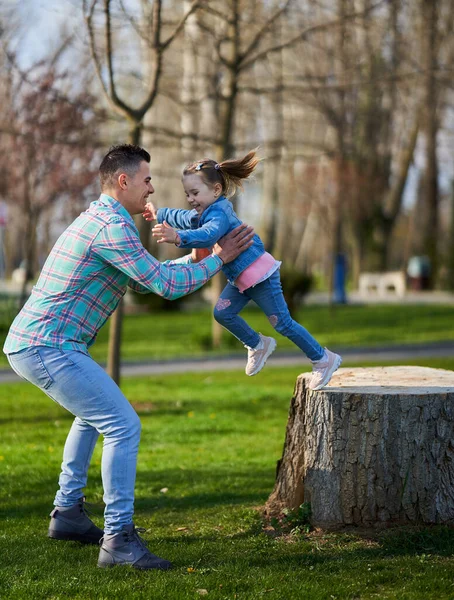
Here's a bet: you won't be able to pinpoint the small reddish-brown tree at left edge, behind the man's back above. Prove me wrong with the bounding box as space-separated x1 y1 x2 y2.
0 64 97 305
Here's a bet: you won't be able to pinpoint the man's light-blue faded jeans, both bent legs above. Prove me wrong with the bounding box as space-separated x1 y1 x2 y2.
8 346 140 533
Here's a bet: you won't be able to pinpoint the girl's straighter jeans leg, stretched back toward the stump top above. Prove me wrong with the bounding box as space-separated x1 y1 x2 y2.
247 271 324 361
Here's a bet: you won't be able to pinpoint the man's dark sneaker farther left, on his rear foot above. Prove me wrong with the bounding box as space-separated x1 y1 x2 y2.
47 498 104 544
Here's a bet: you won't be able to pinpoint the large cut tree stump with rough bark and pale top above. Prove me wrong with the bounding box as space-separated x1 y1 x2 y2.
266 367 454 529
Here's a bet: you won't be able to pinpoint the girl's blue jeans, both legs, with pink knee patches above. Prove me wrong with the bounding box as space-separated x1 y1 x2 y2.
214 270 324 360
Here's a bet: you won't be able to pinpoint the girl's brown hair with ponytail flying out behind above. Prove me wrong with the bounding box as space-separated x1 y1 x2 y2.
183 150 260 197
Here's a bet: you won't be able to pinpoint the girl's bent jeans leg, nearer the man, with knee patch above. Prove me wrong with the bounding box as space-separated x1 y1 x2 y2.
214 283 260 348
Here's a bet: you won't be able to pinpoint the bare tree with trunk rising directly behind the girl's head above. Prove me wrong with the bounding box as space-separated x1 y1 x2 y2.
176 0 292 347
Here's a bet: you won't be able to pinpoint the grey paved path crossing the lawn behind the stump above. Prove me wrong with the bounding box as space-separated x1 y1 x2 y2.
0 340 454 383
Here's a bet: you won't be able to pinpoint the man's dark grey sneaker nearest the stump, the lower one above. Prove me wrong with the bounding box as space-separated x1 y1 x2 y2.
98 523 172 571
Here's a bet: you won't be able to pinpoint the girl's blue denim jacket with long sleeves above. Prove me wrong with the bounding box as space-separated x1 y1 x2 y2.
157 196 265 283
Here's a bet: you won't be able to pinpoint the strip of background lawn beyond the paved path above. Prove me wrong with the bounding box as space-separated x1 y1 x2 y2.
0 305 454 366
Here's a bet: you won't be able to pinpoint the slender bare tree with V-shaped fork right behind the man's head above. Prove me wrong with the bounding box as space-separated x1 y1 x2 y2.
83 0 202 383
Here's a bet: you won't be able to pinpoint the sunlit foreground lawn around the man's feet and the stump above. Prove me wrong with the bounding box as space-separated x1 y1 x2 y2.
0 359 454 600
